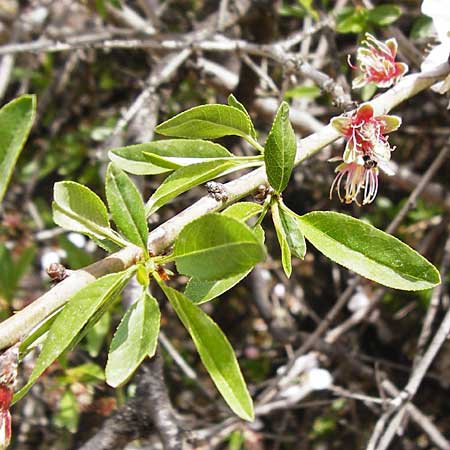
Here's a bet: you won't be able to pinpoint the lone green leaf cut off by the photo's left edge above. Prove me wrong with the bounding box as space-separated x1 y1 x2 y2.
0 95 36 203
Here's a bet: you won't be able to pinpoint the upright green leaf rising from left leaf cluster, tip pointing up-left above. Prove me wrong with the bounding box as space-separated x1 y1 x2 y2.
106 164 148 249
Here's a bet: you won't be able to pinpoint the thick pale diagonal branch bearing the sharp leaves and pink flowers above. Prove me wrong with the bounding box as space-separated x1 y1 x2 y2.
0 63 450 349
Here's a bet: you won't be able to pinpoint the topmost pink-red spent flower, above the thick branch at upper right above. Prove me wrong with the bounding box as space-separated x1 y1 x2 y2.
349 33 408 89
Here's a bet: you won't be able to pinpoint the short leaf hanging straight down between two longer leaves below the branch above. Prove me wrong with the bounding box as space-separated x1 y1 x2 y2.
105 292 161 387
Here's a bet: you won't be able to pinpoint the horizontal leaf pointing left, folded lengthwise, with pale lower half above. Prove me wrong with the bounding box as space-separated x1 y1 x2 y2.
109 139 233 175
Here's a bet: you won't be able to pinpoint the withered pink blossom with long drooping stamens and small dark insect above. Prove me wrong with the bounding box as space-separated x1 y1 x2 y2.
330 103 401 206
